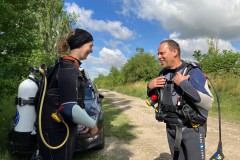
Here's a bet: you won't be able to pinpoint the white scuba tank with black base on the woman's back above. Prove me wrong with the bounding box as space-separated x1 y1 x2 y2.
9 72 38 155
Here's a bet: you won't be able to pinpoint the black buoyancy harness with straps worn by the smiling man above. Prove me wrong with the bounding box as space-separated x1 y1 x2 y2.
155 62 207 151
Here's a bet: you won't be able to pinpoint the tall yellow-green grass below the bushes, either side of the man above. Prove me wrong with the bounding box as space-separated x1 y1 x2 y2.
104 74 240 123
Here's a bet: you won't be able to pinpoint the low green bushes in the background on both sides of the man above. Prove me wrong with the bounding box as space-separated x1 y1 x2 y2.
94 38 240 88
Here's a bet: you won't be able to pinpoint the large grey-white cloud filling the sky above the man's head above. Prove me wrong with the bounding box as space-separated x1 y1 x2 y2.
122 0 240 40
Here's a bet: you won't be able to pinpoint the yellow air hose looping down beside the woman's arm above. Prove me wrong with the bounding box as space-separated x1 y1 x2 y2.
38 68 69 149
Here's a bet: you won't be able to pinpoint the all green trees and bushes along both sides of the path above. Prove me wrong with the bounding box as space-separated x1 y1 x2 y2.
0 0 240 100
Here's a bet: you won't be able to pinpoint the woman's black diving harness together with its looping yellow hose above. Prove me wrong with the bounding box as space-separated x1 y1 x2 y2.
36 56 86 149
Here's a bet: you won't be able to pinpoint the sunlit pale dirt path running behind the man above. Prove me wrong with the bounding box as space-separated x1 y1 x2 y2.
97 90 240 160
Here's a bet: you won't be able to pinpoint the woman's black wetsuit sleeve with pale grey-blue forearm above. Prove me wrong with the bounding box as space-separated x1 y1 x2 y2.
58 62 96 128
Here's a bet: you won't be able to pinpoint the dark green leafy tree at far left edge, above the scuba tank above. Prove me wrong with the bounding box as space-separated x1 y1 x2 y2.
0 0 38 84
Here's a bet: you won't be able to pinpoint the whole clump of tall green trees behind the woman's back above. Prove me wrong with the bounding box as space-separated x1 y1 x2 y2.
0 0 73 95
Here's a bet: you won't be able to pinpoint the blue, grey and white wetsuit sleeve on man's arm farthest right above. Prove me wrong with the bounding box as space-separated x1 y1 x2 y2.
180 68 213 110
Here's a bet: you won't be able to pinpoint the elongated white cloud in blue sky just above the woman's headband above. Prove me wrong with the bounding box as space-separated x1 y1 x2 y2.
65 3 135 40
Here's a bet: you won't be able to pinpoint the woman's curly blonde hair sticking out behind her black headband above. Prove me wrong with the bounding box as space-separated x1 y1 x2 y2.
56 29 75 54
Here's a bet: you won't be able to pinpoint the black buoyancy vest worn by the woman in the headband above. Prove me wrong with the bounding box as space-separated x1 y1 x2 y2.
38 56 87 131
